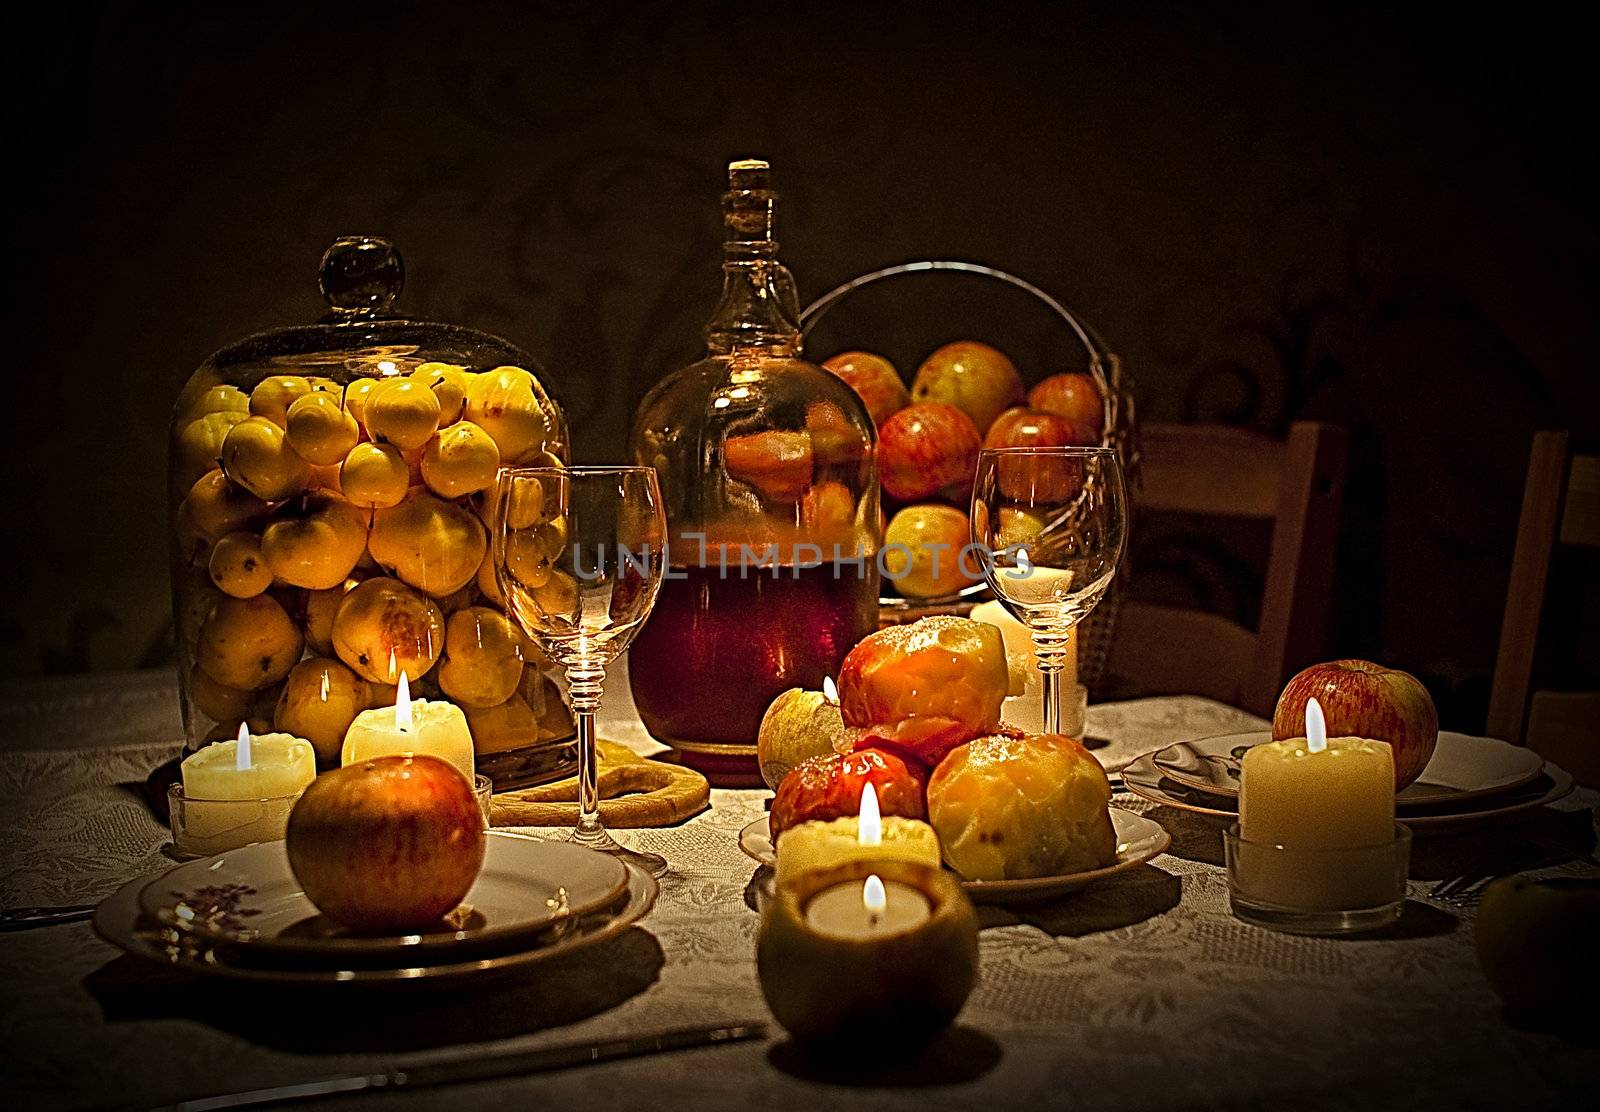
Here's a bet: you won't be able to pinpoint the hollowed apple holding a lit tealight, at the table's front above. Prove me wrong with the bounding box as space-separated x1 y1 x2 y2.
757 861 978 1058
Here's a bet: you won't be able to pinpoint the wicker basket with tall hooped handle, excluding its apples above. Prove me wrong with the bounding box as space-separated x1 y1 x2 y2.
800 261 1139 690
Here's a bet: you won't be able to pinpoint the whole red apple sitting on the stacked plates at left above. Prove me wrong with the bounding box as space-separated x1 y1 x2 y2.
286 757 485 934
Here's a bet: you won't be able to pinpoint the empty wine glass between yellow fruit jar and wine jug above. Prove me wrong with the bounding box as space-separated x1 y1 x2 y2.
491 467 667 877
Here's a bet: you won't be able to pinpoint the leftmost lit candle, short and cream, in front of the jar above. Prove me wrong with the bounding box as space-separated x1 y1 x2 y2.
168 725 317 856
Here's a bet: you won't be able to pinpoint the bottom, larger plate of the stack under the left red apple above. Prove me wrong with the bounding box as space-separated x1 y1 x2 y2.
93 866 661 987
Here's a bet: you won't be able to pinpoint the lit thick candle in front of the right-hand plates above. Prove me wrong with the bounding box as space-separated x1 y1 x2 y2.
1224 699 1410 933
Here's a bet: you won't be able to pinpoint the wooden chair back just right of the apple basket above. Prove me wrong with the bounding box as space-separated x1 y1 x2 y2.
1107 421 1349 717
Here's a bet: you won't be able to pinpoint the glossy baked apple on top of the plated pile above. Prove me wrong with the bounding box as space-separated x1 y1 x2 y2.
838 614 1010 766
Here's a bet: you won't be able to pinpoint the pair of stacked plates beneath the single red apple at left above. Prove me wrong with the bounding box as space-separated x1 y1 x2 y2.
94 830 658 986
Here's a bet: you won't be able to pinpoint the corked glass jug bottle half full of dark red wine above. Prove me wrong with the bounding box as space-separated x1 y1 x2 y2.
629 162 882 782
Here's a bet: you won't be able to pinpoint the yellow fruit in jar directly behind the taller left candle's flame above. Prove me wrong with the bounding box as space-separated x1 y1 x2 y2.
333 576 445 681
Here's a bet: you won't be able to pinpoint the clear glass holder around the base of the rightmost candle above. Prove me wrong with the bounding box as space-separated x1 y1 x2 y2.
1222 822 1411 934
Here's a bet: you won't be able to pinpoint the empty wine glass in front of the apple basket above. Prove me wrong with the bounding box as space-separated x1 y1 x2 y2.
971 448 1128 733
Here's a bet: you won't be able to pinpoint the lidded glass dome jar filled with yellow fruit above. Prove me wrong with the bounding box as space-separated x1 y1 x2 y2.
168 237 574 789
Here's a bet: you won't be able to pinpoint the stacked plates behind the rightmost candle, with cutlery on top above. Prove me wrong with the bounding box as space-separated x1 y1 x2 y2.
1122 730 1573 832
